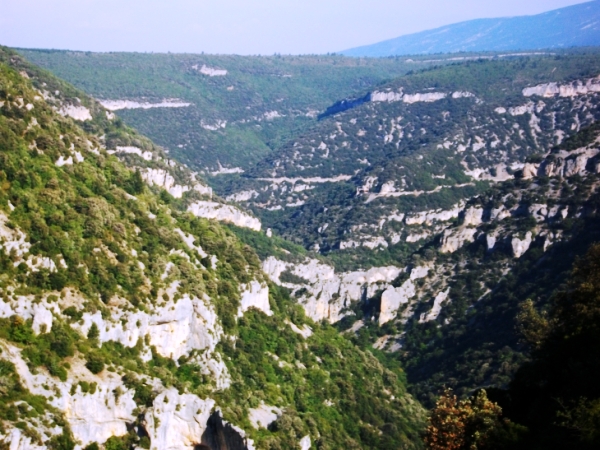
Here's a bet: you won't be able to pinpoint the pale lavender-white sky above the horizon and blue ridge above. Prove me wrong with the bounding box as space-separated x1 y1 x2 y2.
0 0 584 55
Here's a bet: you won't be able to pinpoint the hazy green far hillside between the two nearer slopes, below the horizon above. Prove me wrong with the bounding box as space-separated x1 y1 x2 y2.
19 49 446 172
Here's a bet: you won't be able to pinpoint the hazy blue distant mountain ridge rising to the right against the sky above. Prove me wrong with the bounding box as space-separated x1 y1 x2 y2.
341 1 600 57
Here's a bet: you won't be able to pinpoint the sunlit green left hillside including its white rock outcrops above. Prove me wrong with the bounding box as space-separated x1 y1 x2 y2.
0 48 423 450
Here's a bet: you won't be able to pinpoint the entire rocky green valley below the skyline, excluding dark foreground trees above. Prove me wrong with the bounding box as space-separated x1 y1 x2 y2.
0 43 600 450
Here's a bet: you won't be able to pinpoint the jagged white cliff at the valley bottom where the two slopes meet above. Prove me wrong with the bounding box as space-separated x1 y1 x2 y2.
263 257 404 323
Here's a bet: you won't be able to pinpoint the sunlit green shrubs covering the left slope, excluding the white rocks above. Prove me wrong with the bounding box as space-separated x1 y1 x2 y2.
0 49 423 450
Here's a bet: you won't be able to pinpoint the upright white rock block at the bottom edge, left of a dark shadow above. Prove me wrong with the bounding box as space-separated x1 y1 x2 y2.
145 388 215 450
